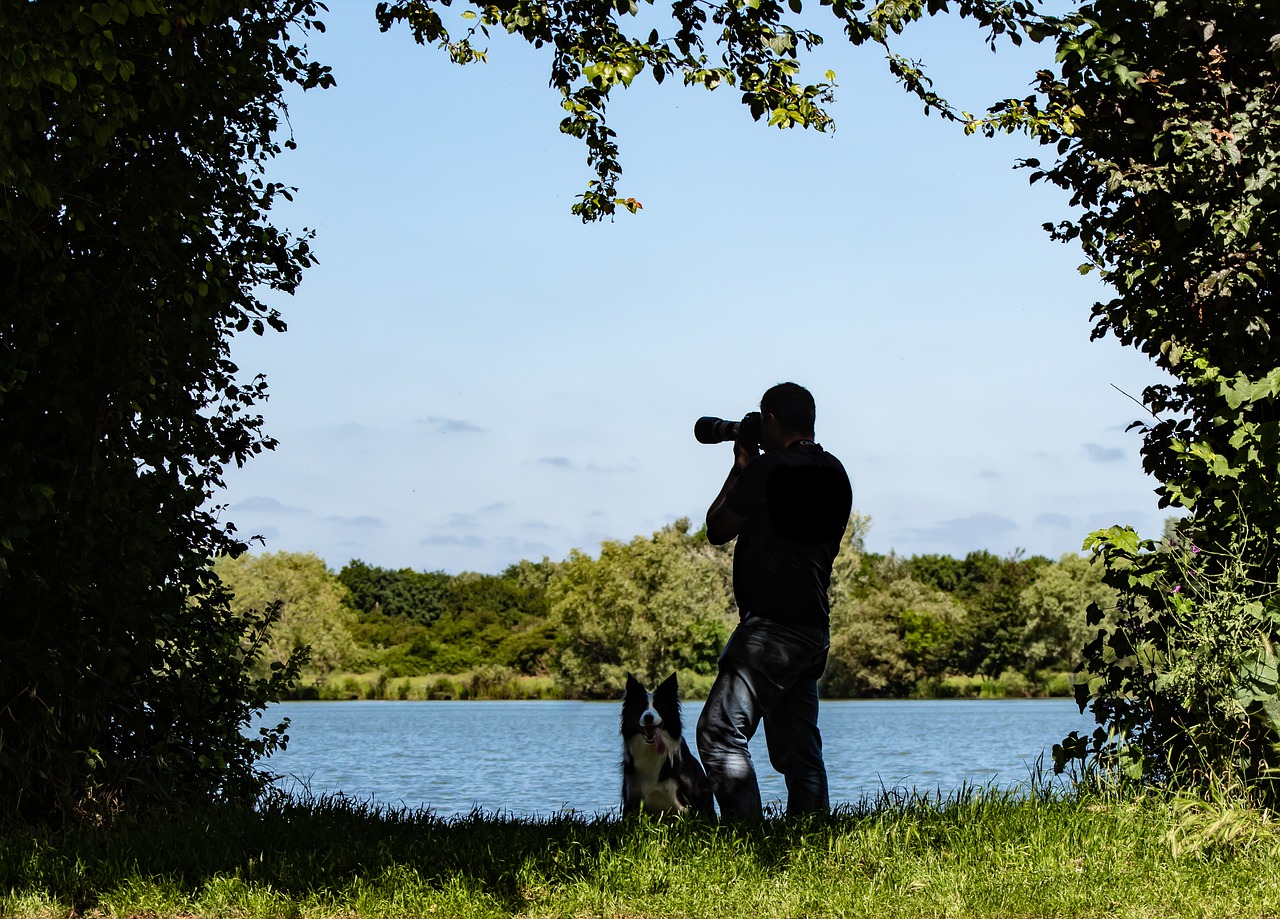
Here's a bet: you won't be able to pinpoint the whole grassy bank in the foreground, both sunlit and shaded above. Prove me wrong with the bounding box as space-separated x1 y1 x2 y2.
0 791 1280 919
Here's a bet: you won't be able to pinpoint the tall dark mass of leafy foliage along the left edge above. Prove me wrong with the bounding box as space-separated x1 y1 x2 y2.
0 0 332 820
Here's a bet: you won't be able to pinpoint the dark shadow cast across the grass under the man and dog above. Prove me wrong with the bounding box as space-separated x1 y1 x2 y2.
0 788 1059 913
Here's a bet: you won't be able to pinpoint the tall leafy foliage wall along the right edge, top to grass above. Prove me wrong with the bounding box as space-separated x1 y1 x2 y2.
973 0 1280 785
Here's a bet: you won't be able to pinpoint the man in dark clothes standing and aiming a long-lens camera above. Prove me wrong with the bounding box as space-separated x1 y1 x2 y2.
698 383 852 820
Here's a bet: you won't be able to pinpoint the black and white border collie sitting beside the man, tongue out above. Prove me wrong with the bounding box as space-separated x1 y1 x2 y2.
622 673 716 820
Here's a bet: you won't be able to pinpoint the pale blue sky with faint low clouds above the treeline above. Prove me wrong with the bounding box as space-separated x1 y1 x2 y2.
219 0 1165 572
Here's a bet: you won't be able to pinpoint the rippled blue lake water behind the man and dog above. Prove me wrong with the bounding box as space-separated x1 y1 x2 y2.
257 699 1093 817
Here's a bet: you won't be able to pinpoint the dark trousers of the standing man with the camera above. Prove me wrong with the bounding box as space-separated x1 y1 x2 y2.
698 617 831 820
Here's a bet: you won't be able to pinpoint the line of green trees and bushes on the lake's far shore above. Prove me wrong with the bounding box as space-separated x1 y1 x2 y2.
215 515 1112 699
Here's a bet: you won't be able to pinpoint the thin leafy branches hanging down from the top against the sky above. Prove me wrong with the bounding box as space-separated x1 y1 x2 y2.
376 0 1036 221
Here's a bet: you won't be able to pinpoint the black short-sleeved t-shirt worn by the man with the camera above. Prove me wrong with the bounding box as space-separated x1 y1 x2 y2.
726 443 854 627
